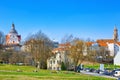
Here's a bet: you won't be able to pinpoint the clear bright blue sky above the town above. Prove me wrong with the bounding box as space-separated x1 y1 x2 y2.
0 0 120 42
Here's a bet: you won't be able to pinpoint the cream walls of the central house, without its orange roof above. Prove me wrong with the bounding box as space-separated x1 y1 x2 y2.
47 51 74 70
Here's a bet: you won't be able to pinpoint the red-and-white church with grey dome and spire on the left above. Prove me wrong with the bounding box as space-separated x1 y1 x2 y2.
6 24 21 45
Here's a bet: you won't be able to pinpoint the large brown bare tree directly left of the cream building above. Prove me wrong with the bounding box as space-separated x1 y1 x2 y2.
25 31 53 68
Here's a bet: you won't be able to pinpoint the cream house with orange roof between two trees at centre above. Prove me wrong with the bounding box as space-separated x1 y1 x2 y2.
47 44 73 70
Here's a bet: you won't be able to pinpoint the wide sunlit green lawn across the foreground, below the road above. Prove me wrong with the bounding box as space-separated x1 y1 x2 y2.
0 65 115 80
